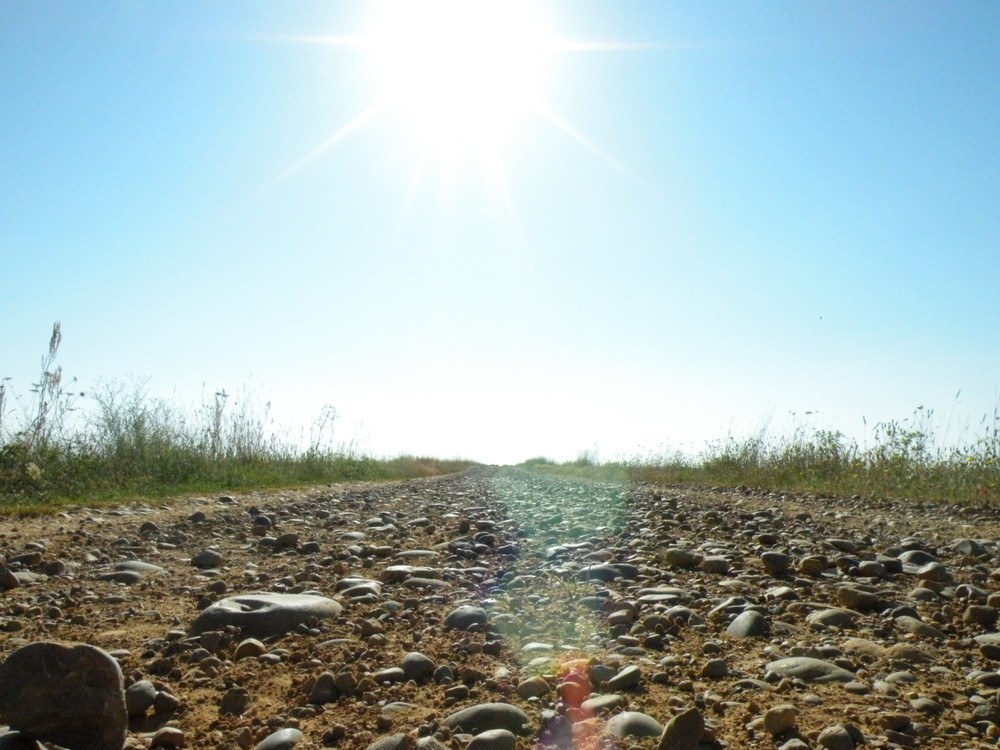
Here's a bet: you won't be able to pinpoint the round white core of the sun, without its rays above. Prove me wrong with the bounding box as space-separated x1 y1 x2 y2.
364 0 556 160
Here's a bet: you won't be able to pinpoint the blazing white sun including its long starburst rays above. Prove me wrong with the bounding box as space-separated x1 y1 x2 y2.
254 0 647 226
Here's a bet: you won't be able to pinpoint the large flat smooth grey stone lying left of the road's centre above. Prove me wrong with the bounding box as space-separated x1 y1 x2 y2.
191 593 342 638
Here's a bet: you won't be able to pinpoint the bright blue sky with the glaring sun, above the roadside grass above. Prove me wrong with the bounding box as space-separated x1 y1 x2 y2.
0 0 1000 463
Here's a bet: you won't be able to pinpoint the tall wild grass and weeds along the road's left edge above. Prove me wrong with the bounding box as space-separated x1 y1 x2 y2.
0 322 472 513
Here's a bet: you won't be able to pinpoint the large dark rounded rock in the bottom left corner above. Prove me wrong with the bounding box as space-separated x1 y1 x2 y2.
0 641 128 750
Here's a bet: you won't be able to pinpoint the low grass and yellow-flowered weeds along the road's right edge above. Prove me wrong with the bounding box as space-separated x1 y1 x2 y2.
522 407 1000 505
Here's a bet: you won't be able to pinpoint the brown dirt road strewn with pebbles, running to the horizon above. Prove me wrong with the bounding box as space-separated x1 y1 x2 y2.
0 469 1000 750
